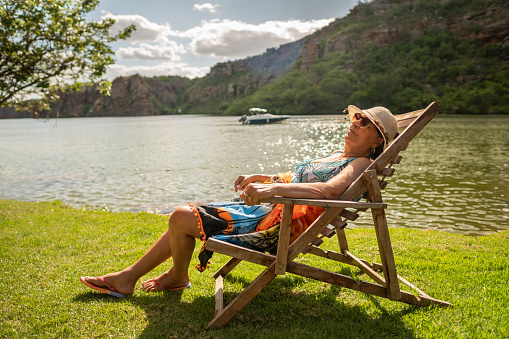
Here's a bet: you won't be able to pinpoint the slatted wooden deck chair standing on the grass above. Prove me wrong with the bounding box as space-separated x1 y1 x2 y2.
206 102 451 328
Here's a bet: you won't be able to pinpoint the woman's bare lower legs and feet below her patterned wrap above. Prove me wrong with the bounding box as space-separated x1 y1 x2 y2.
87 206 200 294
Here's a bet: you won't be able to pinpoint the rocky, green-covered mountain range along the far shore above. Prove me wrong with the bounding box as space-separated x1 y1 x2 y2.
0 0 509 117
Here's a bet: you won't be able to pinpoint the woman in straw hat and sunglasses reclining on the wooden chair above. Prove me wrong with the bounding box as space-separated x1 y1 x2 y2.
80 105 397 298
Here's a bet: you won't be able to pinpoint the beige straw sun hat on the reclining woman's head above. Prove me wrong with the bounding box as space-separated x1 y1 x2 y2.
348 105 398 149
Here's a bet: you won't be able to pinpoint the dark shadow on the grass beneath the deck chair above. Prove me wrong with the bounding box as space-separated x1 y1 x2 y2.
74 274 418 338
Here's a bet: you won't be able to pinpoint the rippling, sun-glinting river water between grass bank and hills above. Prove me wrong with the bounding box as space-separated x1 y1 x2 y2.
0 115 509 235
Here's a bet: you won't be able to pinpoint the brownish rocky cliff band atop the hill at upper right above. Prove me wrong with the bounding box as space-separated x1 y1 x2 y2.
299 0 509 72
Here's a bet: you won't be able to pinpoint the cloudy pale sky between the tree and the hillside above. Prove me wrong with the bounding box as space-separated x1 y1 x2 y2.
87 0 358 80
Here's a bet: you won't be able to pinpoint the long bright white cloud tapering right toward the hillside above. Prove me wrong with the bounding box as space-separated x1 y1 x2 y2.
179 19 334 59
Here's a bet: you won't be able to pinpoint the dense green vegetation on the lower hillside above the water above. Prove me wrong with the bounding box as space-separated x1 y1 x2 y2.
228 30 509 114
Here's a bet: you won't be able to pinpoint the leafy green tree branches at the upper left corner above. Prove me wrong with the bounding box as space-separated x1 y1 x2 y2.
0 0 136 109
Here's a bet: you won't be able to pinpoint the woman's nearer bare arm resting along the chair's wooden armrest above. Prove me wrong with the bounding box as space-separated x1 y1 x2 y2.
241 158 371 205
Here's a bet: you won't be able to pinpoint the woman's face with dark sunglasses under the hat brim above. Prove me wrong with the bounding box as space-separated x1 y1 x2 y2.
345 113 383 151
